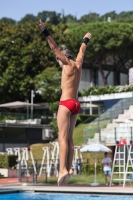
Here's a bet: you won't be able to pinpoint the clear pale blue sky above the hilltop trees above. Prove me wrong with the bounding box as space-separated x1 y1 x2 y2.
0 0 133 21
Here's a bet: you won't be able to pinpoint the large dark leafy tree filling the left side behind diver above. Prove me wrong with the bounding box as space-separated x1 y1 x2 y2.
0 23 66 102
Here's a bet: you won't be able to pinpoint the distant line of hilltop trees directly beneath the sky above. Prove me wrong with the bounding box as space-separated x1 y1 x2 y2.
0 10 133 25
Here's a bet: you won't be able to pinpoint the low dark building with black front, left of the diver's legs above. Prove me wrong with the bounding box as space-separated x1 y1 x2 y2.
0 122 54 152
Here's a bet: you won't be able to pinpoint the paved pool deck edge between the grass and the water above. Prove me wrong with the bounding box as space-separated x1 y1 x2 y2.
0 178 133 195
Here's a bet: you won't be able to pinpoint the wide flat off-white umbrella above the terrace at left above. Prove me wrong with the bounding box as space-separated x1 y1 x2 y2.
0 101 39 108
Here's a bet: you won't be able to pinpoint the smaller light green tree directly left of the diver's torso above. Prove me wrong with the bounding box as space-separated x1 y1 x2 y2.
36 67 61 136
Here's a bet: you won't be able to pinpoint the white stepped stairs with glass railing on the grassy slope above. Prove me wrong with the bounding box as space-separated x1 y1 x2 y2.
86 98 133 146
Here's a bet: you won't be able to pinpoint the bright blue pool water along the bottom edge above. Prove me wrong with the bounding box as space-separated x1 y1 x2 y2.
0 192 133 200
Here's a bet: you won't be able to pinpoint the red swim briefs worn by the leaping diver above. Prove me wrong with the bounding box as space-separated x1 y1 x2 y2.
59 99 80 115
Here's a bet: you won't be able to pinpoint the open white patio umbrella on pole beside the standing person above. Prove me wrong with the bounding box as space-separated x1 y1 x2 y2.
80 143 112 186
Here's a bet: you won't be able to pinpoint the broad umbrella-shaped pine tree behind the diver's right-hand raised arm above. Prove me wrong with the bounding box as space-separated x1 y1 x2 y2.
69 22 133 85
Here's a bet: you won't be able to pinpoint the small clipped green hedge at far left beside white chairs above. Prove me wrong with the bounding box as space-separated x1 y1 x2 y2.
0 154 18 169
